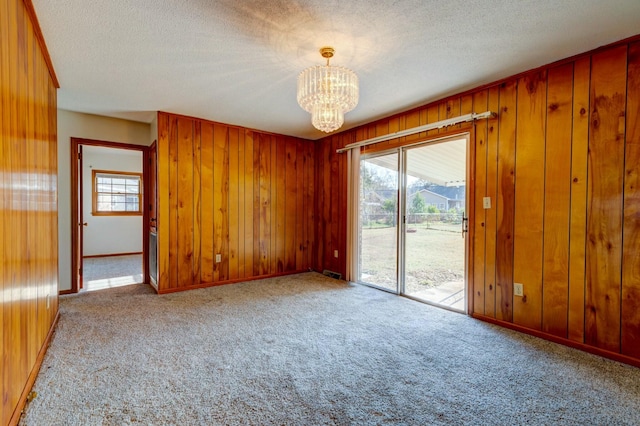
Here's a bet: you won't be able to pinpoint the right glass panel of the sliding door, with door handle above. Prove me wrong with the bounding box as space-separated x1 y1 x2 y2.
403 138 467 311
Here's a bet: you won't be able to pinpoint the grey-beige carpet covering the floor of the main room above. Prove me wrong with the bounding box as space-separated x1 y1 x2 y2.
21 273 640 425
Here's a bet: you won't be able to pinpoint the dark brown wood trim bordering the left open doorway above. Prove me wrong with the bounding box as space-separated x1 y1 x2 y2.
70 137 149 295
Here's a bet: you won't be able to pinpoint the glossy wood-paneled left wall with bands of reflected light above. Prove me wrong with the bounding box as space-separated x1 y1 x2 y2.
0 0 58 425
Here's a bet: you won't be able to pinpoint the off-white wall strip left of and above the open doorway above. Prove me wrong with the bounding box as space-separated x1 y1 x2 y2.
58 110 150 290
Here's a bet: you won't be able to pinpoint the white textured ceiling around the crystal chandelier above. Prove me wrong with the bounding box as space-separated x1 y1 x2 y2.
33 0 640 139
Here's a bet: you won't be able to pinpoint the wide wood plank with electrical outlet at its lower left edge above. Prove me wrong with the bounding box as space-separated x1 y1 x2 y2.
513 72 547 330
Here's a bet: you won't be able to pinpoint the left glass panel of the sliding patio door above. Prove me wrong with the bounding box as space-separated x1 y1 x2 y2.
358 152 398 292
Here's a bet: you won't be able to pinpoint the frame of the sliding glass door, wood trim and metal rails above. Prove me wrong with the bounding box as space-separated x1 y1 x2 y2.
357 130 476 315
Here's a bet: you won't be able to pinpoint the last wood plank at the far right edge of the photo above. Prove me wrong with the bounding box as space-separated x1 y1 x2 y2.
621 42 640 358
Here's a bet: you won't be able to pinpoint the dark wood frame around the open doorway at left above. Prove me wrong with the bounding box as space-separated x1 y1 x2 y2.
68 137 149 294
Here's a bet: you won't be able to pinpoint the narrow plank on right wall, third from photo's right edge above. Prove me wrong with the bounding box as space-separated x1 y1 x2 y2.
567 57 591 342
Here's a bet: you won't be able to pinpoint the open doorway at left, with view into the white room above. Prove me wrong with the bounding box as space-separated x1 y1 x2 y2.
71 138 149 293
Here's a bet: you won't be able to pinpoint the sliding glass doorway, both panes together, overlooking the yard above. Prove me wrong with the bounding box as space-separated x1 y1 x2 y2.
357 134 469 312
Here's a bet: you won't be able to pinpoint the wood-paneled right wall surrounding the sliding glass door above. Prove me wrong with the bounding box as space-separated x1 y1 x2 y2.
315 37 640 365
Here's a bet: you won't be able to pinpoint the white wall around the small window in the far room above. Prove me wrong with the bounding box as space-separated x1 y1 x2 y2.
82 146 143 256
